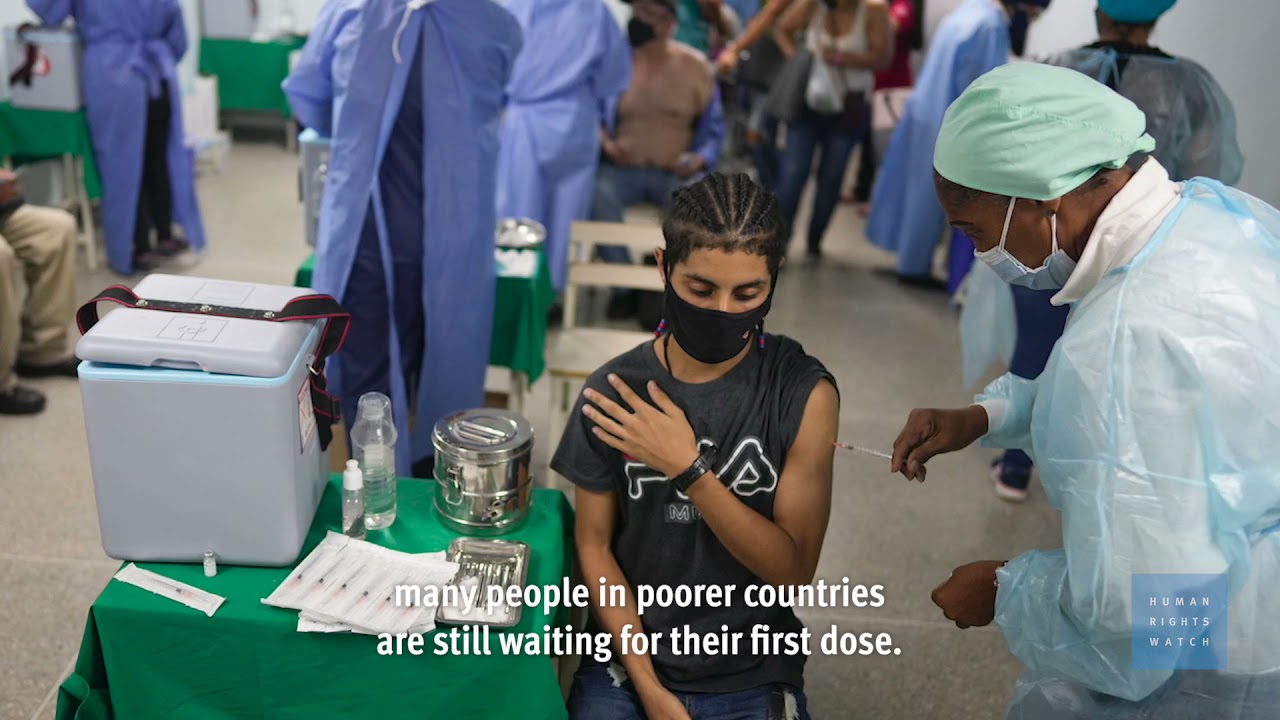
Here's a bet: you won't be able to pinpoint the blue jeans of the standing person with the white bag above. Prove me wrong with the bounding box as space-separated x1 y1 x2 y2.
778 108 863 252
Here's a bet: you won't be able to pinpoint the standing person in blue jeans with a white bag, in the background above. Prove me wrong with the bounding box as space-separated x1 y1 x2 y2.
774 0 893 258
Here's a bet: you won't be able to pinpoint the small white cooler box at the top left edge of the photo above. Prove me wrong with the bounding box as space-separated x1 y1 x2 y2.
4 27 84 113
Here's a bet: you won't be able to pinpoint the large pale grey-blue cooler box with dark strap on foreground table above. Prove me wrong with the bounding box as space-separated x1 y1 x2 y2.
76 274 344 566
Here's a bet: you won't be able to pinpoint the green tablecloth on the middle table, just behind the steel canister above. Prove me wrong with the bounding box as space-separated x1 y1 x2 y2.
293 250 556 384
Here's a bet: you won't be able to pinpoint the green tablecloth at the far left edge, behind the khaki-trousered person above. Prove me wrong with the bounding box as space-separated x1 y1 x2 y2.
0 102 102 200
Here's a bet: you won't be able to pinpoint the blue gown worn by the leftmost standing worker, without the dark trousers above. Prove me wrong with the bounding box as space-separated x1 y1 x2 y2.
27 0 205 274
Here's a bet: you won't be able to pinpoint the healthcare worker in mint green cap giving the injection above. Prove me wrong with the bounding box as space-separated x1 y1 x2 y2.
891 63 1280 720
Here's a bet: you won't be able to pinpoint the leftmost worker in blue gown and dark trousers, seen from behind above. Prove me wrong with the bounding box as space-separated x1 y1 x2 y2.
27 0 205 274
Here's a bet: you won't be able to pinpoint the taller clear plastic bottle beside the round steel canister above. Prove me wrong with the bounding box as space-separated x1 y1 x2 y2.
351 392 396 530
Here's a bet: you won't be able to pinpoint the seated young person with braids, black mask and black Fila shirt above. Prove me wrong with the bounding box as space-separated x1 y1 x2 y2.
552 174 840 720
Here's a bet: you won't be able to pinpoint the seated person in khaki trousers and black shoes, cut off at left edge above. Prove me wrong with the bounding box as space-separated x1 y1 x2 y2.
0 170 79 415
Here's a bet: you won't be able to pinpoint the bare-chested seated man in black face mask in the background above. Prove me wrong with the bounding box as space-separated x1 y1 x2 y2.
591 0 724 239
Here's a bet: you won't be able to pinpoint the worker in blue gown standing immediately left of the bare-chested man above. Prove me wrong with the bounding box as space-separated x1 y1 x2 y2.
498 0 631 291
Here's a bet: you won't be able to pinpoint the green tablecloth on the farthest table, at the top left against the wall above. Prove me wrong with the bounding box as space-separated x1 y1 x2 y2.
200 37 306 118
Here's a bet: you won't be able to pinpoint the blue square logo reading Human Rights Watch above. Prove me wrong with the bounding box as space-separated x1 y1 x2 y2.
1133 574 1228 670
